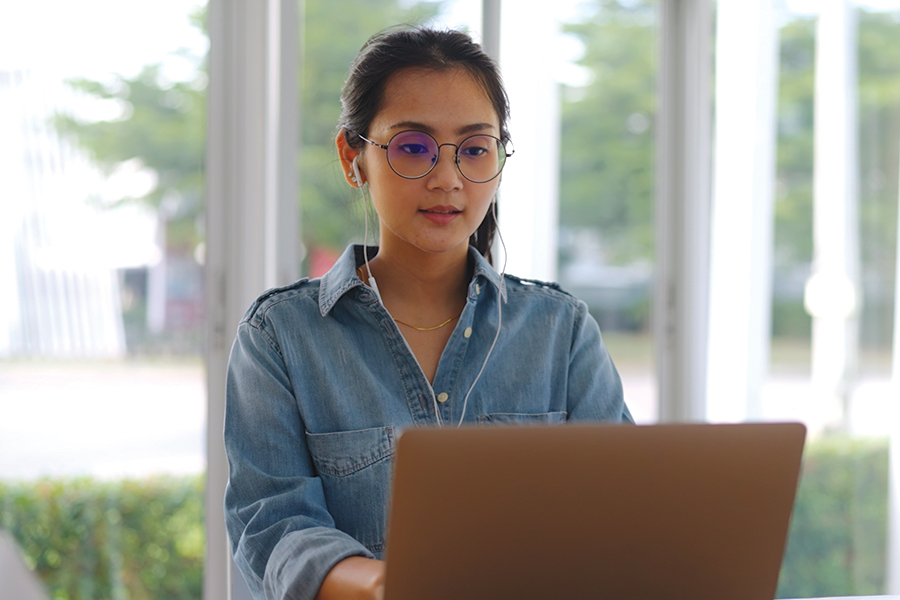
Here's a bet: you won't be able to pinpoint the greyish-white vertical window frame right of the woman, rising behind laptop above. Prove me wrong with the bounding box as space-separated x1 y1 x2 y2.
653 0 713 421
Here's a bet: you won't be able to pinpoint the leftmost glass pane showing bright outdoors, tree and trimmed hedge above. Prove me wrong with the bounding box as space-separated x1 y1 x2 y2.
0 0 208 599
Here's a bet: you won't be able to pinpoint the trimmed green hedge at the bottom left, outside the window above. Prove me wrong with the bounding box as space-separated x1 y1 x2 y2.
0 477 205 600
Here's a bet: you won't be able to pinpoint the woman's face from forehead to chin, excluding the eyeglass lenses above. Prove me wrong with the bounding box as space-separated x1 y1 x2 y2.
346 69 500 255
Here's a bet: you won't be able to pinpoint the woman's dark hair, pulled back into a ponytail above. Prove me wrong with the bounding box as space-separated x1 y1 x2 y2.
338 27 509 260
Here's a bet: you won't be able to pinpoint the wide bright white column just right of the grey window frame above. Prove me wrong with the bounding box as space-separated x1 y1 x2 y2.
706 0 778 422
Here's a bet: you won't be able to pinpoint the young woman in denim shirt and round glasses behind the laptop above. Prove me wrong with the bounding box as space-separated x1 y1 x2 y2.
225 29 631 600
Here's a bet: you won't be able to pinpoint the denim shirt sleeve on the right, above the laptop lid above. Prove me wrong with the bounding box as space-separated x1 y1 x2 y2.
568 300 634 423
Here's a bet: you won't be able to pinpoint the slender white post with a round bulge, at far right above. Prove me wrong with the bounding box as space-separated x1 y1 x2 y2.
805 0 860 428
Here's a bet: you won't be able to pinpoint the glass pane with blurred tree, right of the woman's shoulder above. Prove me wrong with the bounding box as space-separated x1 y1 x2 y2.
559 1 658 423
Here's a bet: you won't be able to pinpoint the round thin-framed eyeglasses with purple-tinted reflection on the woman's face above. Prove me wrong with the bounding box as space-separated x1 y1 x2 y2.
357 130 515 183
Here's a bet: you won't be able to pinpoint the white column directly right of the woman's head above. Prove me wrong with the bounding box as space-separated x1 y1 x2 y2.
495 2 559 280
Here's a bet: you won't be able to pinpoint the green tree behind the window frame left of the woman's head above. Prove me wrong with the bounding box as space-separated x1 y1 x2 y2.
56 0 442 272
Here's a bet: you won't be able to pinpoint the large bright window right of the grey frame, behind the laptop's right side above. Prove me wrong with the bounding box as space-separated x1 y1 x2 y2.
707 2 900 597
